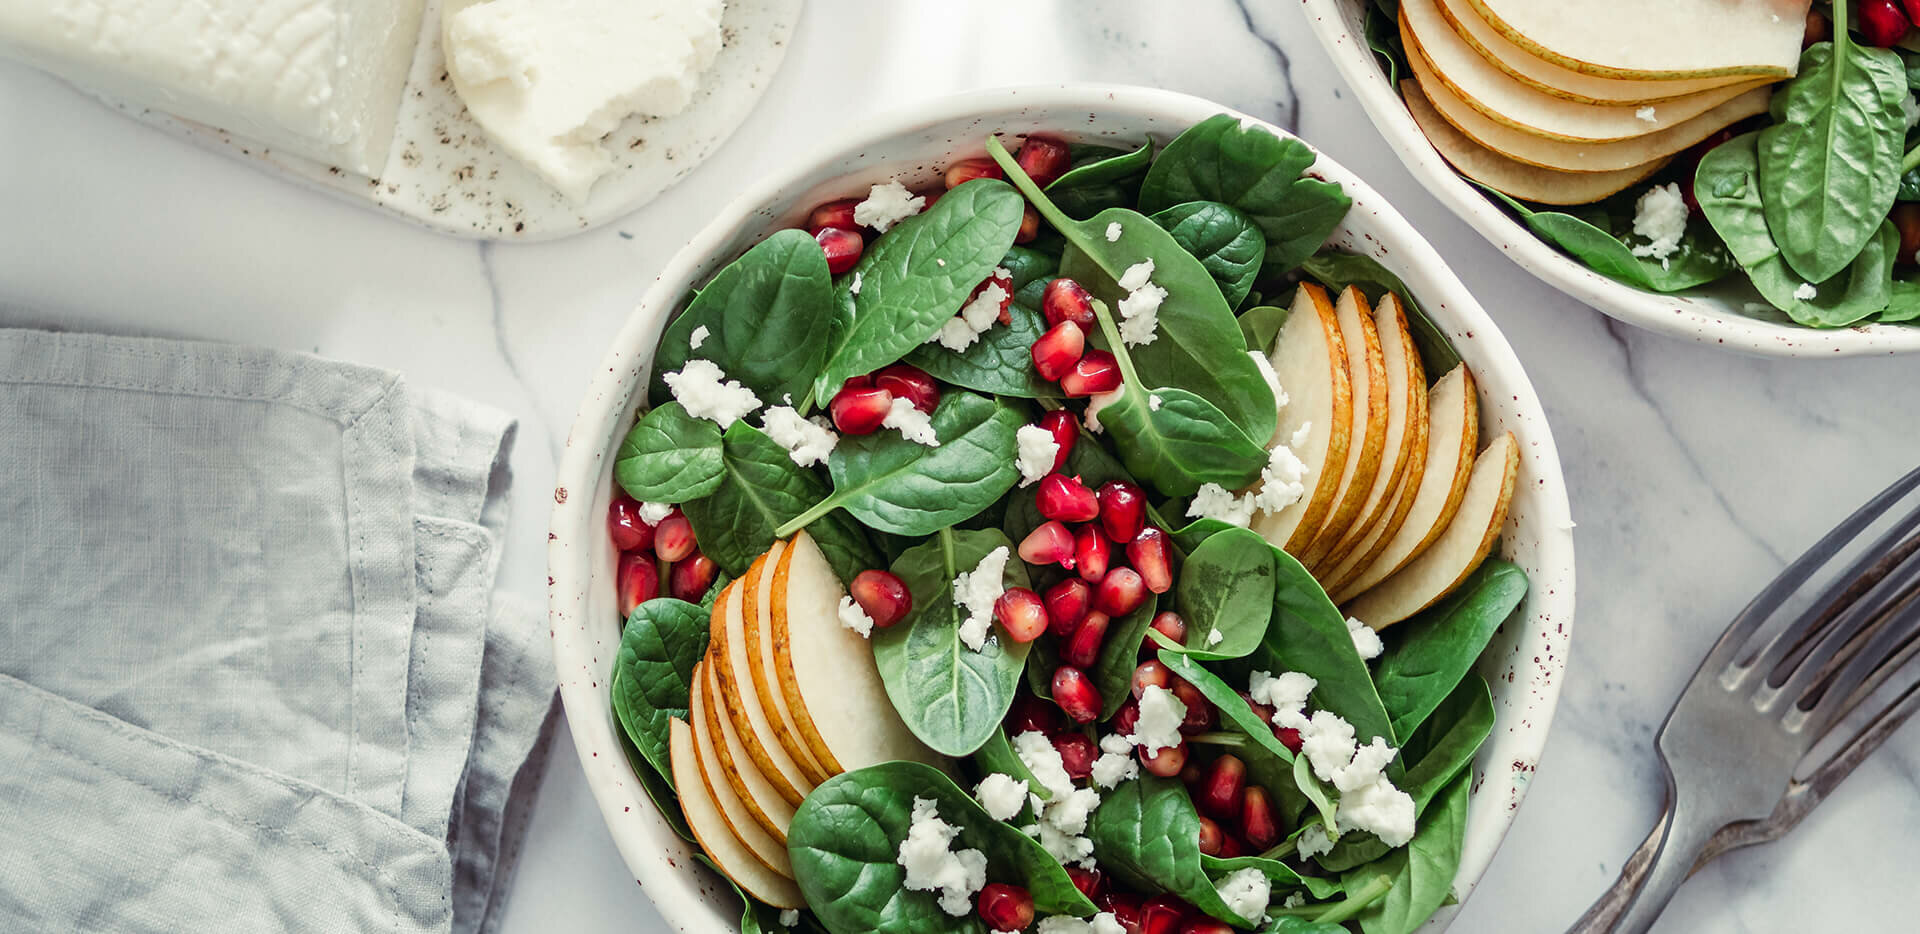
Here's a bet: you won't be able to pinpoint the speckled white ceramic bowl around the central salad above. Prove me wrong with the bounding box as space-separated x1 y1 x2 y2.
547 86 1574 932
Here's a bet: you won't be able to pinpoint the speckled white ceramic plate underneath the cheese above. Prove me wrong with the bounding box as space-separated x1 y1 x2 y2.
88 0 801 240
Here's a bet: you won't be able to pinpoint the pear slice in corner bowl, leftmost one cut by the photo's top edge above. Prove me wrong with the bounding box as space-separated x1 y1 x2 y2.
1400 0 1768 142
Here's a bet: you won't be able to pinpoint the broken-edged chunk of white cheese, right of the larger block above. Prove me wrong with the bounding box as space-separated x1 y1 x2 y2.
442 0 724 204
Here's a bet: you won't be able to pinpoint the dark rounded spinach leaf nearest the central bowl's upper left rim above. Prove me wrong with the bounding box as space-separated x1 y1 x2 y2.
647 231 837 409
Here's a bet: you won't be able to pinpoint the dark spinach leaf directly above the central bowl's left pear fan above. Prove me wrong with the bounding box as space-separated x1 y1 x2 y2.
682 419 879 580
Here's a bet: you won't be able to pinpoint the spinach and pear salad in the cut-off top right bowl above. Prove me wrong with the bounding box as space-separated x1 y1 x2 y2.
1367 0 1920 329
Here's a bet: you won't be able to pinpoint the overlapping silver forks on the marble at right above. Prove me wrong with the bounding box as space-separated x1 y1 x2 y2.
1567 469 1920 934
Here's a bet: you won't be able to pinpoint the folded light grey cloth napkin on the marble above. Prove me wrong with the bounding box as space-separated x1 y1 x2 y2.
0 331 555 934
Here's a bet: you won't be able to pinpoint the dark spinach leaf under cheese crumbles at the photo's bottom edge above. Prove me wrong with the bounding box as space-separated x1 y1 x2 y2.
787 761 1094 934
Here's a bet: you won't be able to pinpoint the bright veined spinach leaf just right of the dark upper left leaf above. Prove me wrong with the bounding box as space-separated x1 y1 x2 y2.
810 179 1025 402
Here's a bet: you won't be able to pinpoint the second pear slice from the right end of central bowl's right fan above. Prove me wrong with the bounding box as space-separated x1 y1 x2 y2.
1327 365 1480 603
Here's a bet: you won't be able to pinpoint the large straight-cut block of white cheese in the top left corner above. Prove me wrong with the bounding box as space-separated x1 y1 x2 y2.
0 0 424 175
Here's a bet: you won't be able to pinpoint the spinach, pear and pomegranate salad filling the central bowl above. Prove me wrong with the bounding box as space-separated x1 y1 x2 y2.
609 115 1526 934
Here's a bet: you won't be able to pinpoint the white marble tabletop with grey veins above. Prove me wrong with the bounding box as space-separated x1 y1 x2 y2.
0 0 1920 934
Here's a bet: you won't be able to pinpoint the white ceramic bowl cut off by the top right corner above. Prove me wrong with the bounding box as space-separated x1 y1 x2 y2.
1302 0 1920 357
